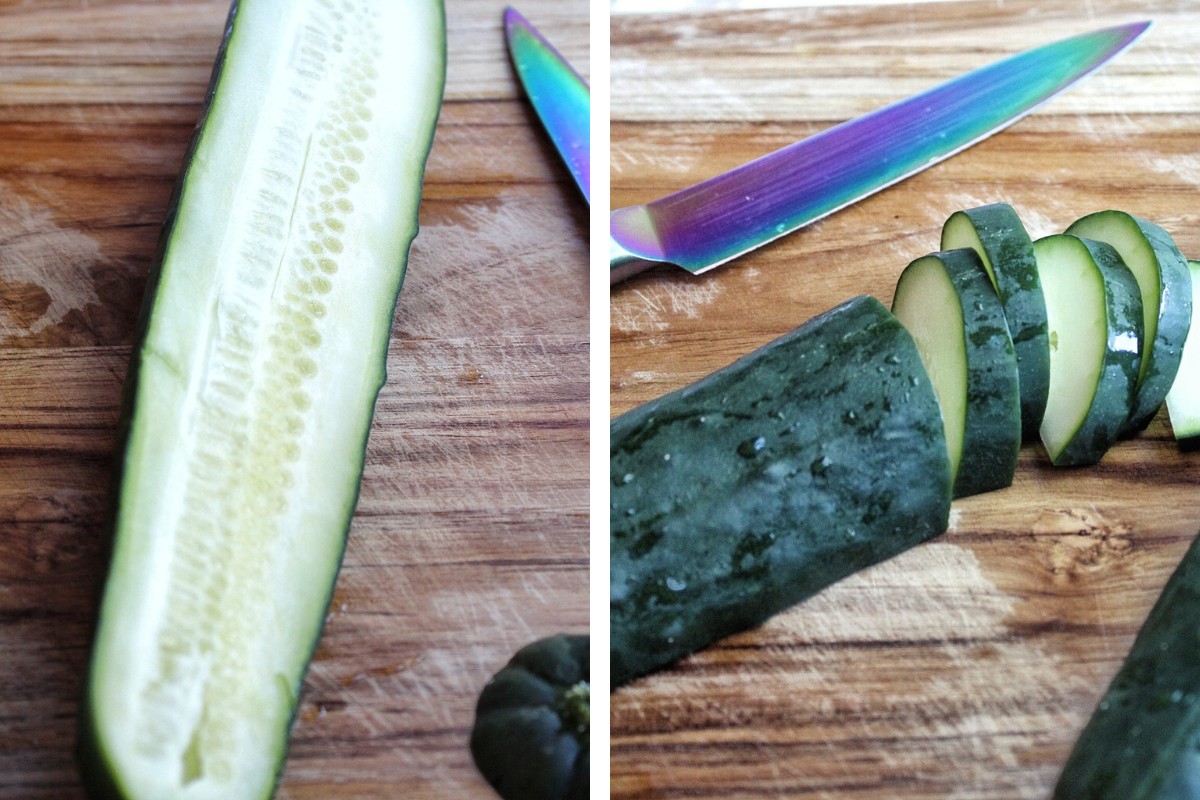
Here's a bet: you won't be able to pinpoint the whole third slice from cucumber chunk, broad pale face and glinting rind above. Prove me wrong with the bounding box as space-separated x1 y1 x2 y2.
1033 234 1142 465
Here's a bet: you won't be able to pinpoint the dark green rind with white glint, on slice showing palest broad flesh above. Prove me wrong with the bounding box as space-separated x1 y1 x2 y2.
1052 234 1142 467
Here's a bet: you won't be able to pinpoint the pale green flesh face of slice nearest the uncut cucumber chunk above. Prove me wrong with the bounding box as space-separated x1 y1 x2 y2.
892 258 967 485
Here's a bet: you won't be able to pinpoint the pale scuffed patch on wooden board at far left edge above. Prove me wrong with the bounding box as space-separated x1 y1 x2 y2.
0 181 101 337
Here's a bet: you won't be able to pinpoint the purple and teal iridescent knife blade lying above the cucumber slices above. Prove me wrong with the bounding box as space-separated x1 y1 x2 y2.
610 22 1150 283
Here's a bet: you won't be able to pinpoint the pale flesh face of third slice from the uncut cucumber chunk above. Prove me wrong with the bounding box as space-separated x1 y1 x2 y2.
1033 236 1108 459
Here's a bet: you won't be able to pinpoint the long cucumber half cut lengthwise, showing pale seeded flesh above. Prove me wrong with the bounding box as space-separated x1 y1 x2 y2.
79 0 445 800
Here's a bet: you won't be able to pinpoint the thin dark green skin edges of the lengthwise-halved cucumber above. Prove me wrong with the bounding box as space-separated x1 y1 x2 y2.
76 0 448 800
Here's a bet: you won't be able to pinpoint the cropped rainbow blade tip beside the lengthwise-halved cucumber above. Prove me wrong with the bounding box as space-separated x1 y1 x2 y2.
504 6 592 203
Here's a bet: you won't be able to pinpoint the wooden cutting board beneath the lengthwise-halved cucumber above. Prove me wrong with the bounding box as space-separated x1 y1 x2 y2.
0 0 588 800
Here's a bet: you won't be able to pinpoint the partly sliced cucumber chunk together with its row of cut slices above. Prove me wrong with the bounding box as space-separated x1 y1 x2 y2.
610 204 1200 687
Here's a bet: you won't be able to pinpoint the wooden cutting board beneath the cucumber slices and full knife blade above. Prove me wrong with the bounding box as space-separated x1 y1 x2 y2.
610 0 1200 800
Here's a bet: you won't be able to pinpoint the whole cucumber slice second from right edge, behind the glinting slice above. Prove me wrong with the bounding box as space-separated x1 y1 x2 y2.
1067 211 1192 434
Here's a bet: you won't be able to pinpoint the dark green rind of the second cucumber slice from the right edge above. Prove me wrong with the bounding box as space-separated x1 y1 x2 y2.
1067 211 1192 435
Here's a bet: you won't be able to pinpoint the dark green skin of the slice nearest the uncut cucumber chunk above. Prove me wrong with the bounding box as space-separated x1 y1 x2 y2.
898 248 1021 499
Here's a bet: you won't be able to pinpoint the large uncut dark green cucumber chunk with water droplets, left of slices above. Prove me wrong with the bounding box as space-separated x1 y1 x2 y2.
610 296 950 687
